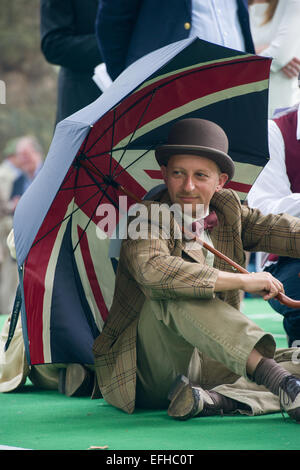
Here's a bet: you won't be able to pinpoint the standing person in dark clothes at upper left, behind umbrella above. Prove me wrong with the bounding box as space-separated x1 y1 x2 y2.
40 0 102 122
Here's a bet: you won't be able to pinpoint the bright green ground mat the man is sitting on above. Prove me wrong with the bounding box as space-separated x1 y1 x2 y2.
0 298 300 455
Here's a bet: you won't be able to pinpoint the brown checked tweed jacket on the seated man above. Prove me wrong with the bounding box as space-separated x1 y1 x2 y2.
93 189 300 413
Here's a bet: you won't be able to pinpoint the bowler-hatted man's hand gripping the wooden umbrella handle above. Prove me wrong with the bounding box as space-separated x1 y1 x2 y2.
242 272 284 300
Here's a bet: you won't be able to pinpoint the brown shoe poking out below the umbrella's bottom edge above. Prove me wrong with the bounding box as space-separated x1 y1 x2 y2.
58 364 94 397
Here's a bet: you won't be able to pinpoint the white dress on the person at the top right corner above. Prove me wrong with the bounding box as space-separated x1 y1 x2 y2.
249 0 300 117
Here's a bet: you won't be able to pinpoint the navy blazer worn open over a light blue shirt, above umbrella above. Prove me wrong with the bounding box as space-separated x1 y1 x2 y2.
96 0 254 80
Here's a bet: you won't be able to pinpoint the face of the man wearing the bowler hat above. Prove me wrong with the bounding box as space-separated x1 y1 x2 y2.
161 155 228 215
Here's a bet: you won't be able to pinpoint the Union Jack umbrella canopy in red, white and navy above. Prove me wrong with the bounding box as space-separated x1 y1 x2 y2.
14 38 271 364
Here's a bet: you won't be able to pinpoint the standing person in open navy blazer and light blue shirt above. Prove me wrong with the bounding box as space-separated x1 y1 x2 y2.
96 0 254 80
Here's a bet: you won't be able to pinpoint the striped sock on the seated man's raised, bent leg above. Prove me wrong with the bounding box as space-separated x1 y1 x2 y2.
253 358 291 396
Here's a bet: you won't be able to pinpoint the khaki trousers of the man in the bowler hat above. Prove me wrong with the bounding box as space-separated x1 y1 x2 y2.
136 298 300 414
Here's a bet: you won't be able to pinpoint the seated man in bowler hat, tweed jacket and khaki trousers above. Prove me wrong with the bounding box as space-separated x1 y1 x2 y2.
94 119 300 422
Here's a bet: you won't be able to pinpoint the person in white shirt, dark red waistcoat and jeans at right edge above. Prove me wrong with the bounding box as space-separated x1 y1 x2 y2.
248 105 300 347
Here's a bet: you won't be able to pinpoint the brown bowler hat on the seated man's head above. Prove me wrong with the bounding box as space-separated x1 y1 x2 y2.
155 118 234 179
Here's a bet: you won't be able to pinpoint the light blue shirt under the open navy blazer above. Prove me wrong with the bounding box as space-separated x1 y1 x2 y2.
190 0 245 51
